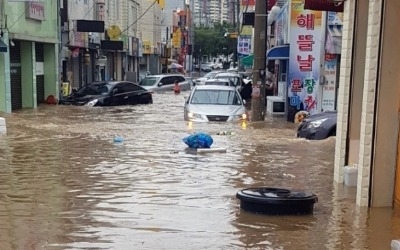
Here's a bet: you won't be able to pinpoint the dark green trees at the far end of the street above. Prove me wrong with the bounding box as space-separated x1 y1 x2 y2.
193 22 237 59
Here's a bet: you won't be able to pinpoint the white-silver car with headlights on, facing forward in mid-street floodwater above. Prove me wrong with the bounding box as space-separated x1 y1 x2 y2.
184 85 247 122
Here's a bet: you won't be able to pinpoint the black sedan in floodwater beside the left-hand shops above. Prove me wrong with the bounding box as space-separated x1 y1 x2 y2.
60 81 153 106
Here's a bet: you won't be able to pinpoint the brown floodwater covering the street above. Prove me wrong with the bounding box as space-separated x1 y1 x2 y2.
0 92 400 250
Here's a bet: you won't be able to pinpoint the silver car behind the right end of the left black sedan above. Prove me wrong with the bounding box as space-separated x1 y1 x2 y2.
139 74 191 91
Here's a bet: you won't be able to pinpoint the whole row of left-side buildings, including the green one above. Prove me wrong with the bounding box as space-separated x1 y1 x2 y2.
0 0 163 112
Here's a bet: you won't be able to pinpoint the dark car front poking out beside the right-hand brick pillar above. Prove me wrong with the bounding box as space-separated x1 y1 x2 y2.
297 111 337 140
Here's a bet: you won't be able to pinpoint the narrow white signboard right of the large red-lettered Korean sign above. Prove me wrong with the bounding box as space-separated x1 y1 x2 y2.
321 54 338 111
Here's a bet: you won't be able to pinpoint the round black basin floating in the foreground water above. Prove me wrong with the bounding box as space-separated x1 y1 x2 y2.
236 187 318 215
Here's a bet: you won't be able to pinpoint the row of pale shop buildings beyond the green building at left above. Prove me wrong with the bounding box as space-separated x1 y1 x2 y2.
61 0 161 87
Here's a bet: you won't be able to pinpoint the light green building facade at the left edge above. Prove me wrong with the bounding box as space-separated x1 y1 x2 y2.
0 0 60 113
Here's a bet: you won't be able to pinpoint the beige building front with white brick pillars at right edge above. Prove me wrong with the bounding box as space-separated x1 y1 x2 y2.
334 0 400 207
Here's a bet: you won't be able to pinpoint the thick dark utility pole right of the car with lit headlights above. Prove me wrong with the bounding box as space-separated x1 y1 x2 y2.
251 0 268 121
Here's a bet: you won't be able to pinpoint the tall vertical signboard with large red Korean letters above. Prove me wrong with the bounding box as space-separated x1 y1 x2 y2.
288 0 322 121
